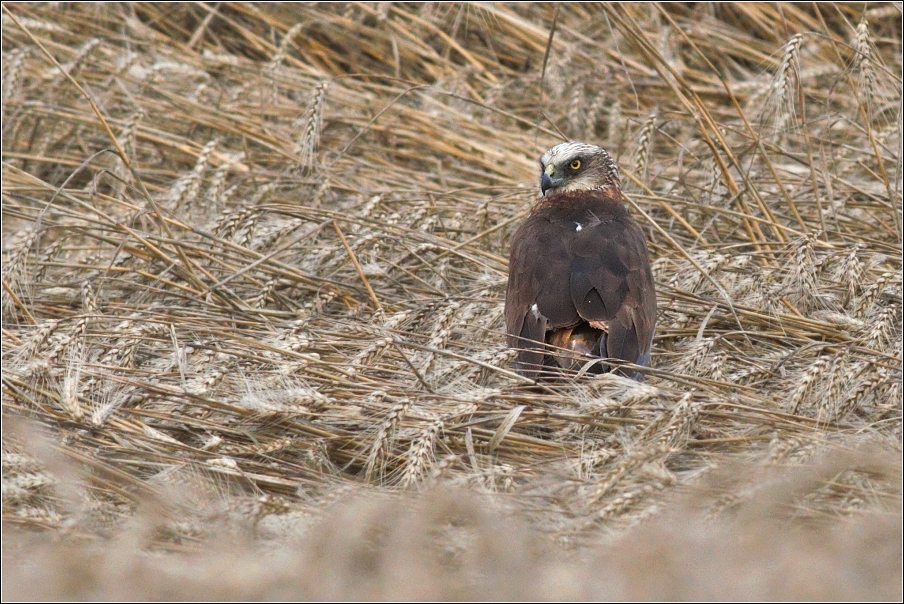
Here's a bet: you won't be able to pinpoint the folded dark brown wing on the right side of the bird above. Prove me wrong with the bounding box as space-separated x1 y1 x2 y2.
568 219 656 365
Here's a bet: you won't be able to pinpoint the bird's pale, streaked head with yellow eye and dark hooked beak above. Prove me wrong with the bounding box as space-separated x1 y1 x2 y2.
540 143 621 197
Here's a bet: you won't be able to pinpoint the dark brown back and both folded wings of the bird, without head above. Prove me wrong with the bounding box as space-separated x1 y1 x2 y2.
505 189 656 376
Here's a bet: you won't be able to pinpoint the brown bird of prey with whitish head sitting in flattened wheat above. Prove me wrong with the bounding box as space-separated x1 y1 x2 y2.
505 142 656 380
